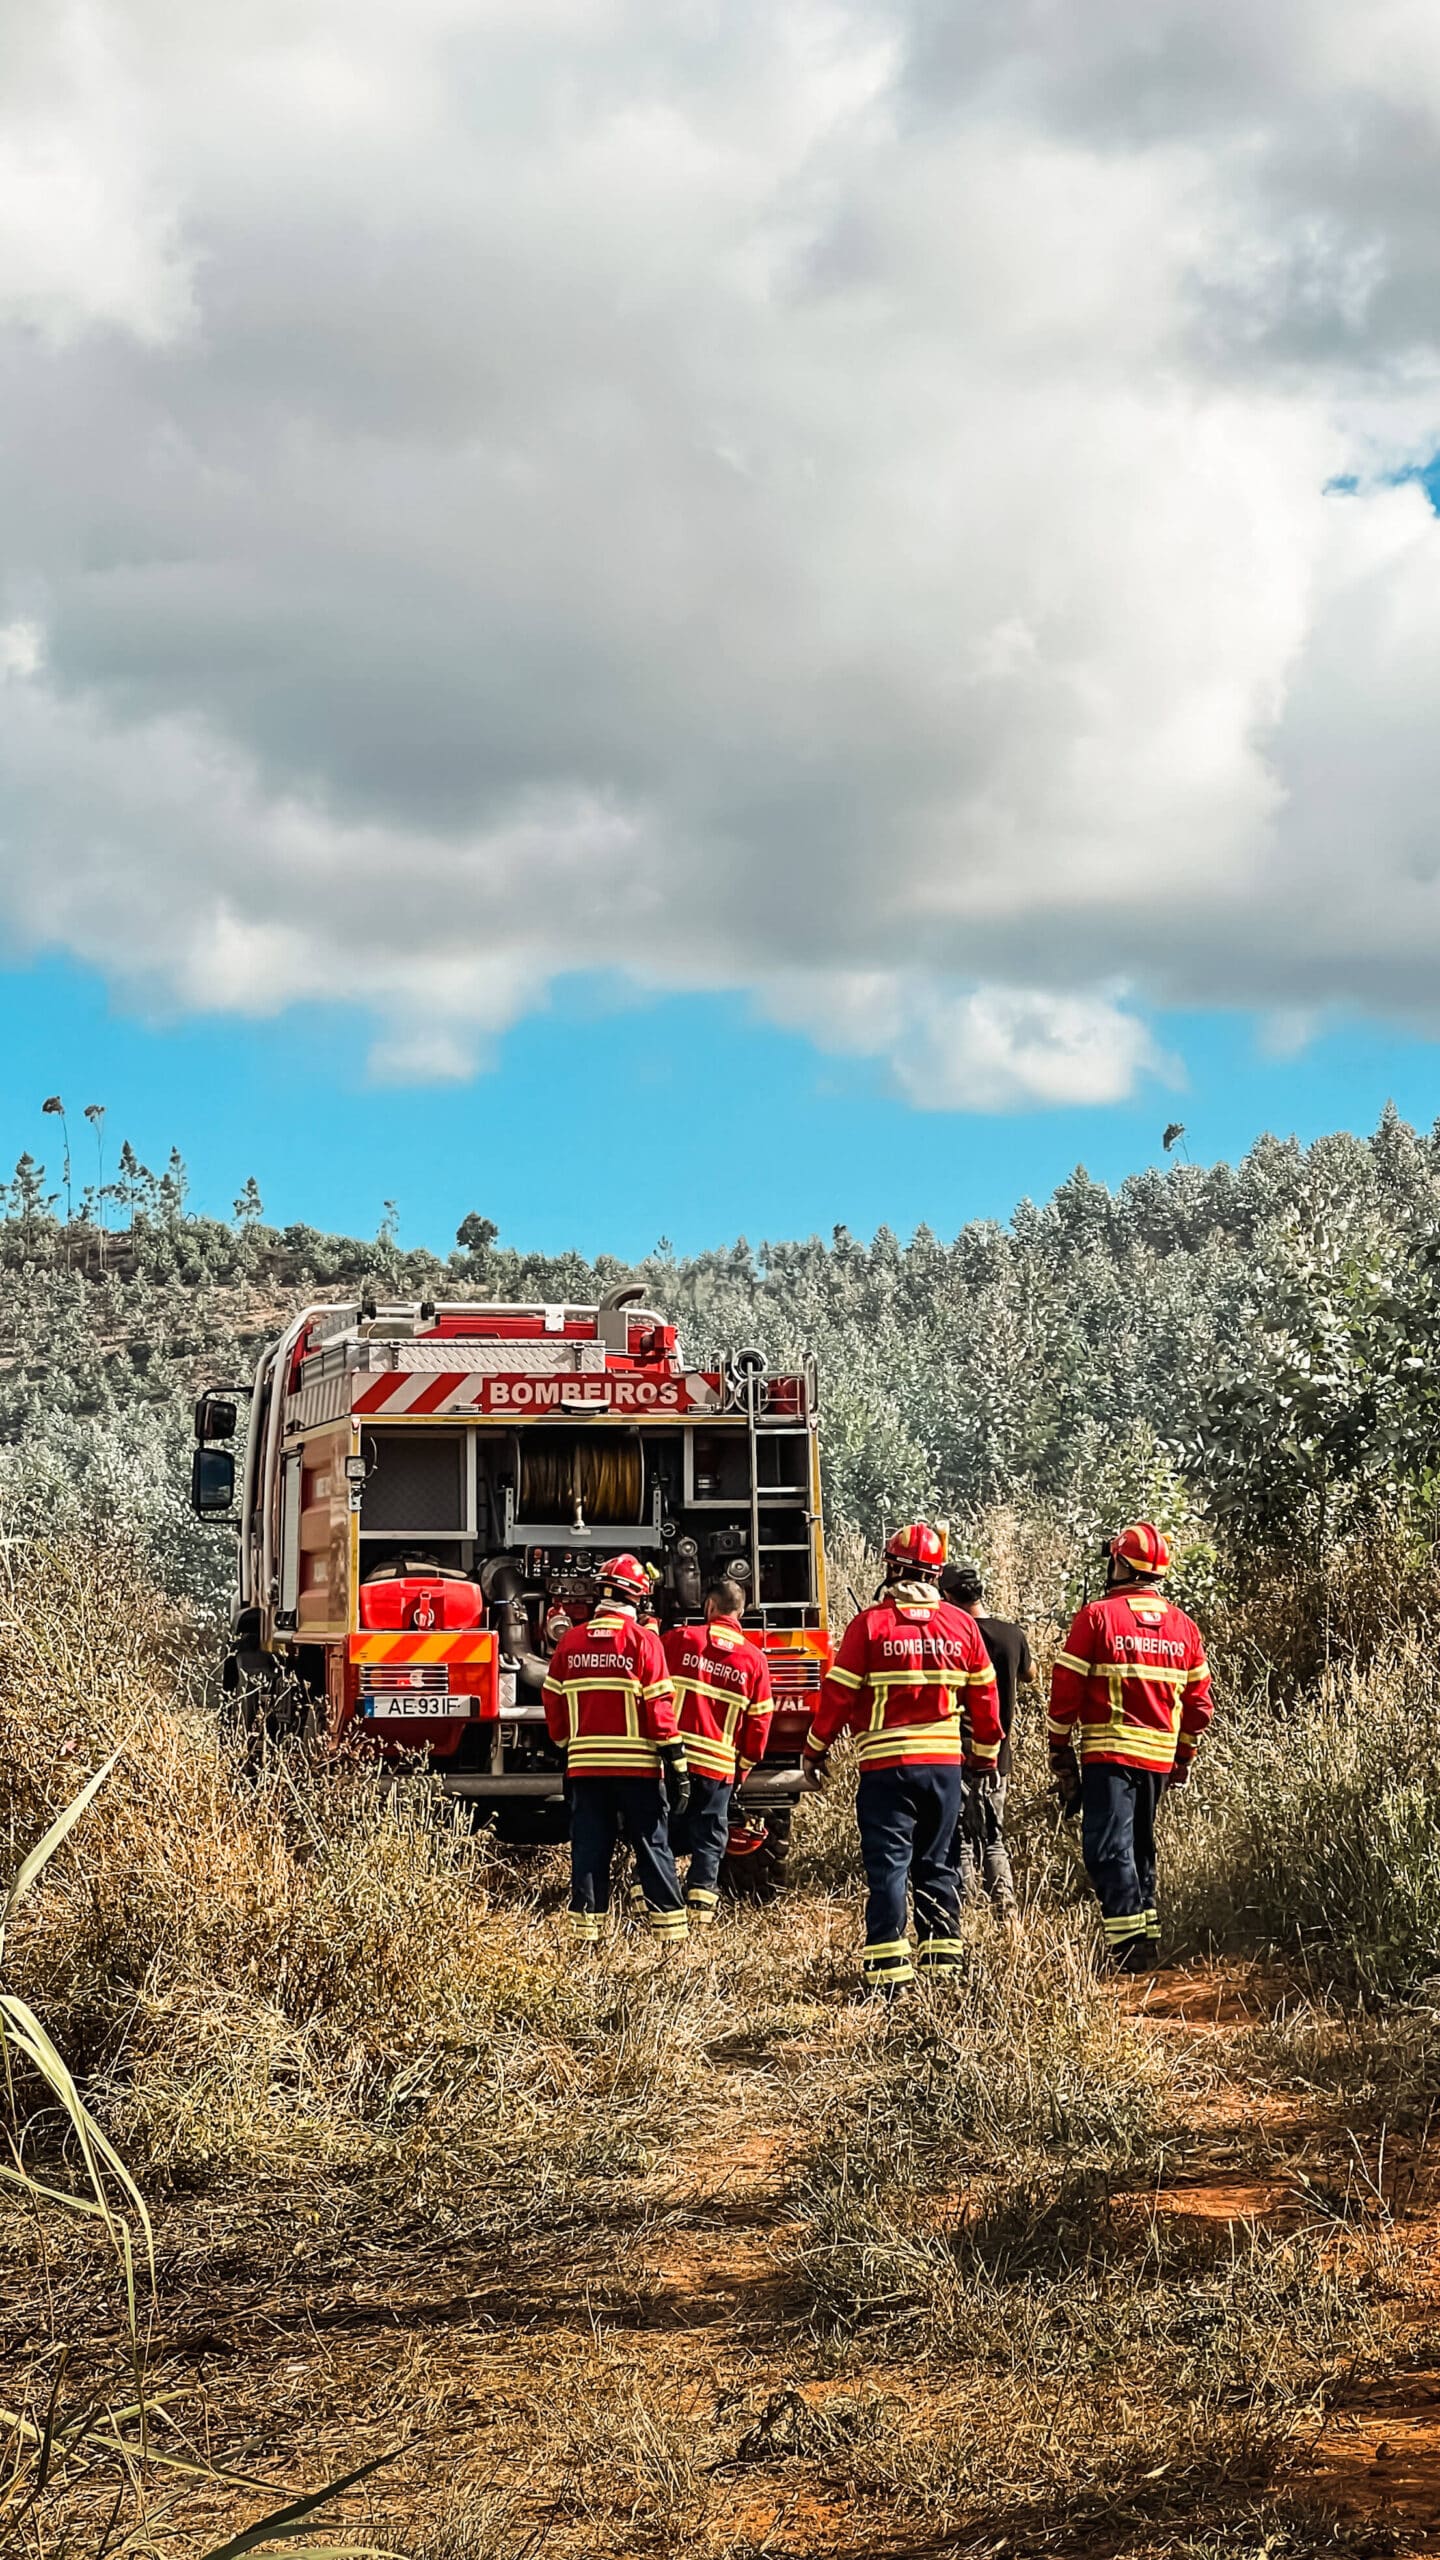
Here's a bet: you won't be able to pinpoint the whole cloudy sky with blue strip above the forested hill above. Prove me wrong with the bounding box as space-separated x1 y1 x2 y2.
0 0 1440 1244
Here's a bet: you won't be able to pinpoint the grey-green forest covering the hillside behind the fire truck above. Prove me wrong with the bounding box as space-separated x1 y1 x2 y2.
0 1106 1440 1638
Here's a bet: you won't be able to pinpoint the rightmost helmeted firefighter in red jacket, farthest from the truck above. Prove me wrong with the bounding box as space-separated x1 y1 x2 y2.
1051 1521 1212 1974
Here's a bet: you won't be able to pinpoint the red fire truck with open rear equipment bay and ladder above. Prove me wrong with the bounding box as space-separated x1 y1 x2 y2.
192 1288 830 1892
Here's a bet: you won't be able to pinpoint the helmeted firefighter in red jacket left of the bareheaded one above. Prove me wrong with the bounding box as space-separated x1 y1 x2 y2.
541 1556 689 1946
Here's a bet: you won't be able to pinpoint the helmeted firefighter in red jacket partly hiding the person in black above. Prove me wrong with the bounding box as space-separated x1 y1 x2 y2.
802 1521 1002 1997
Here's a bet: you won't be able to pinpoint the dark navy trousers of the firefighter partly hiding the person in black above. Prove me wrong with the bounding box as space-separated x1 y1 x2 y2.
856 1761 961 1989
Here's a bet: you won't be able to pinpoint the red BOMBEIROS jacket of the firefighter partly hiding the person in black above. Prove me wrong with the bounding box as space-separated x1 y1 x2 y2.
805 1582 1002 1774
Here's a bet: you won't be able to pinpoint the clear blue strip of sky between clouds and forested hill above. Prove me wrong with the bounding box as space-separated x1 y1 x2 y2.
0 963 1440 1257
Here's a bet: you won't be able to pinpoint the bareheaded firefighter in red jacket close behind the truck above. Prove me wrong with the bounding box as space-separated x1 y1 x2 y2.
666 1577 771 1928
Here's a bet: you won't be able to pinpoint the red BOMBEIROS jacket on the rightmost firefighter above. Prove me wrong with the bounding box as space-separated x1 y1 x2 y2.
1051 1587 1212 1777
